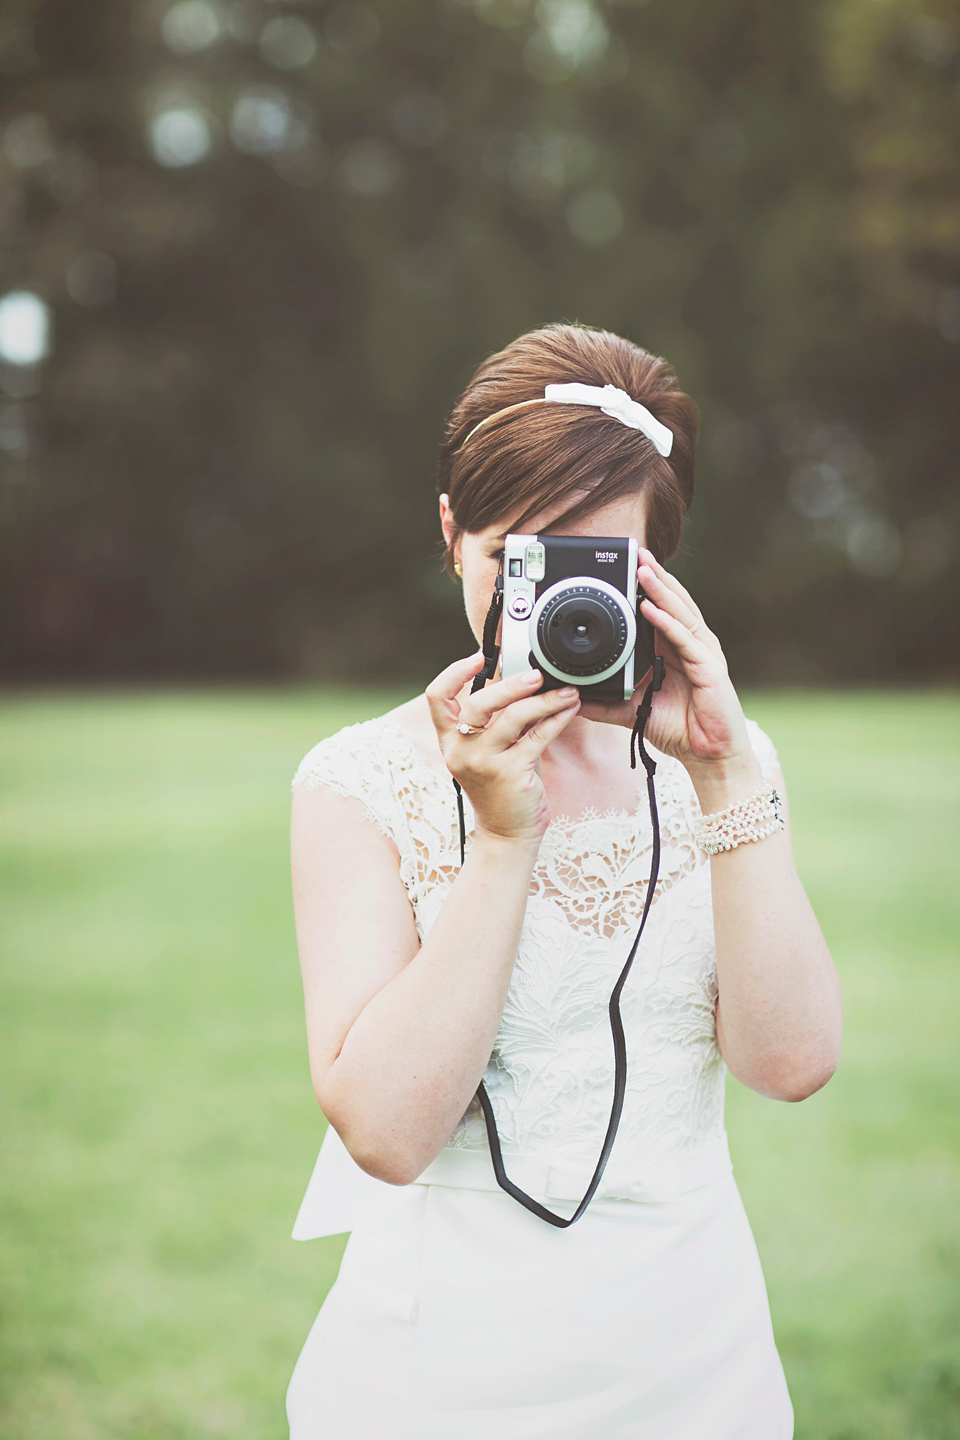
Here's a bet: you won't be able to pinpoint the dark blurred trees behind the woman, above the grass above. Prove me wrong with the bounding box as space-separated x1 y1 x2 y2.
0 0 960 681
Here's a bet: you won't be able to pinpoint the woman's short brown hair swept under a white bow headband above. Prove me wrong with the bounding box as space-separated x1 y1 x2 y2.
438 325 698 570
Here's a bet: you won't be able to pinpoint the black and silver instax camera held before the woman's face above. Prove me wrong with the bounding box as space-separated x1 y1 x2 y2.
499 536 655 703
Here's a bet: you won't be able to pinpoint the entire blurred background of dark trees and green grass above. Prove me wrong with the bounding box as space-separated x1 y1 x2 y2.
0 0 960 1440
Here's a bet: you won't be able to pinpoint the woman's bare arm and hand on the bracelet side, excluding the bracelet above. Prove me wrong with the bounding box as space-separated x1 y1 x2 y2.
583 550 842 1100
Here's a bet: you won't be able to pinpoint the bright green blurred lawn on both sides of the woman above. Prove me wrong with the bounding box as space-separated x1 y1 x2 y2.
0 691 960 1440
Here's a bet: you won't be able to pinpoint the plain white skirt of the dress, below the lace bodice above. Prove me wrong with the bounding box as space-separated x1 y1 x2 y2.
286 1159 793 1440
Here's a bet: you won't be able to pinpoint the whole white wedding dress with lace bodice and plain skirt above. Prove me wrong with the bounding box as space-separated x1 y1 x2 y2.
286 717 793 1440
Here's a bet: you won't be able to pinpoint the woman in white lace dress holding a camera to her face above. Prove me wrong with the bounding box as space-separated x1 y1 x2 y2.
288 325 841 1440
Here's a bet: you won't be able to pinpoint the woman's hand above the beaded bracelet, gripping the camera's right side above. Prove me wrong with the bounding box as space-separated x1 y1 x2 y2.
580 549 756 770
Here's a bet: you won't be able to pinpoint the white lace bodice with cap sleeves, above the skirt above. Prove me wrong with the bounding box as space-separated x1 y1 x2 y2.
294 717 777 1172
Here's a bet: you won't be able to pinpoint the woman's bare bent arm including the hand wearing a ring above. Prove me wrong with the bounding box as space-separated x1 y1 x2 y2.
292 658 577 1185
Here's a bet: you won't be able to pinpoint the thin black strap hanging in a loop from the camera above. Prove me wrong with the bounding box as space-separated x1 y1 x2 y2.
453 575 664 1230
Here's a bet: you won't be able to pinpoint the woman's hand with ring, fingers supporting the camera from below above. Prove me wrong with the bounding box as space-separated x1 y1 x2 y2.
426 654 580 844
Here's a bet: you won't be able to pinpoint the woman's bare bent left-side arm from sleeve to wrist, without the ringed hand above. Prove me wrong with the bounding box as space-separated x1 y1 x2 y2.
294 789 538 1185
